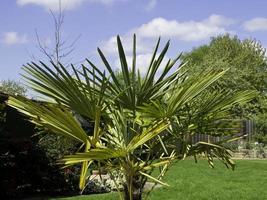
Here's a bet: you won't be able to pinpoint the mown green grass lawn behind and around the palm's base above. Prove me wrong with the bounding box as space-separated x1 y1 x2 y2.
51 160 267 200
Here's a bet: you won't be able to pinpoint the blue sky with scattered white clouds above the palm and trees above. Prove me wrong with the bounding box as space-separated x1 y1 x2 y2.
0 0 267 80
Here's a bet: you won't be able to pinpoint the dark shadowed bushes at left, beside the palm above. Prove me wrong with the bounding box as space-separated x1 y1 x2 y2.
0 108 79 199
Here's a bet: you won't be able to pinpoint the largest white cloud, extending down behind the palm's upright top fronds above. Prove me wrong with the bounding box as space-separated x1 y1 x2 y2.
100 15 234 74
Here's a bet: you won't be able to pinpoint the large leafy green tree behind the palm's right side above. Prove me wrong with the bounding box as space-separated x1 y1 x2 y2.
182 35 267 143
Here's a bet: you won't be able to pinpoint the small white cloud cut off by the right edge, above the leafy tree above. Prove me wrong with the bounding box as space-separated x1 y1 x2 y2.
243 17 267 32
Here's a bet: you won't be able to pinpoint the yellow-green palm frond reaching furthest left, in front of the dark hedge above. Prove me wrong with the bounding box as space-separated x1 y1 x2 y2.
7 97 89 143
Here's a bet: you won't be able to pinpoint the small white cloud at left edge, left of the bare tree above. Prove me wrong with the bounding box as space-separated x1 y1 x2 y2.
1 32 28 45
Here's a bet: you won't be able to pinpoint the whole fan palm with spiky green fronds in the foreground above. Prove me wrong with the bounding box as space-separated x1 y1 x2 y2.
8 35 255 200
